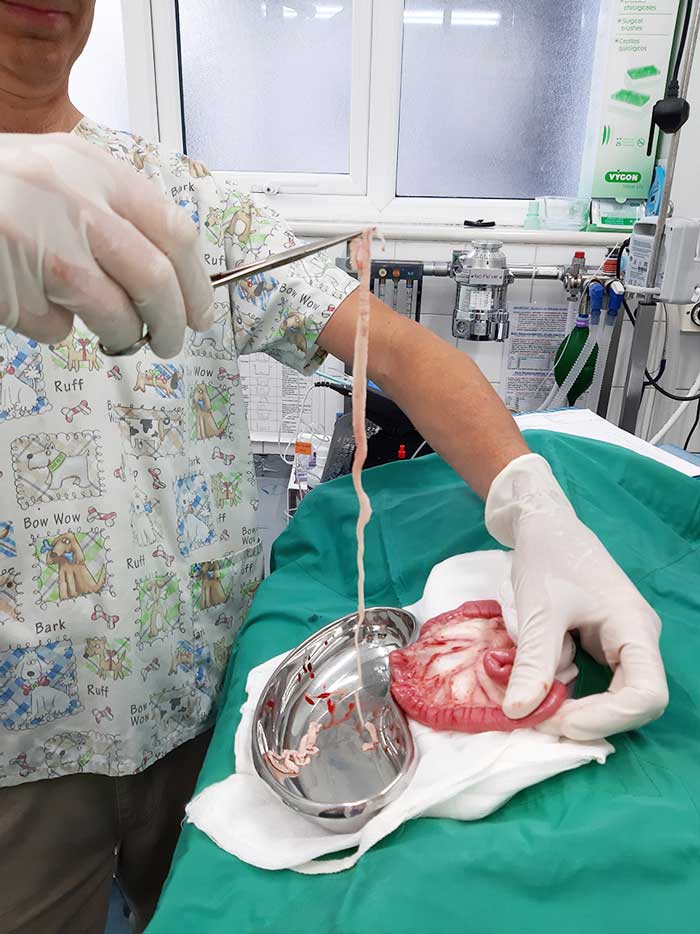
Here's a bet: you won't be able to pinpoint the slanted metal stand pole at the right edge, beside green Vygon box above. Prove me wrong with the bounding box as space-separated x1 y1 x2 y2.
620 0 700 434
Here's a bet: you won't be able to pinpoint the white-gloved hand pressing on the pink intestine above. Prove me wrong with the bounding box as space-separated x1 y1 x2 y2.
486 454 668 740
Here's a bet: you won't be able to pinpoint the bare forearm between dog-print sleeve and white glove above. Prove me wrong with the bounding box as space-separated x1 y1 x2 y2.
321 292 528 498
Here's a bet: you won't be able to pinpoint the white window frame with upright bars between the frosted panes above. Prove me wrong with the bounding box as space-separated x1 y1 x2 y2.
122 0 608 227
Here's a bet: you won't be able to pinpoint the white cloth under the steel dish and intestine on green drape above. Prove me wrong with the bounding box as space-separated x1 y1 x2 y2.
187 551 614 875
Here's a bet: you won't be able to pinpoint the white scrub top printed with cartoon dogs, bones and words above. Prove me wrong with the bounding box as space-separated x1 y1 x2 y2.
0 119 356 785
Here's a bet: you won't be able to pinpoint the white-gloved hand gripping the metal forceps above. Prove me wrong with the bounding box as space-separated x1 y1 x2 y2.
0 133 214 357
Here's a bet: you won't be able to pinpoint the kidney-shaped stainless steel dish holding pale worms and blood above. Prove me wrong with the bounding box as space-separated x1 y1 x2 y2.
252 607 418 833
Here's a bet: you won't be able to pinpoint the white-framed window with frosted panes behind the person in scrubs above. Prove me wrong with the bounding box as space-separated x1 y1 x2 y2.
127 0 617 225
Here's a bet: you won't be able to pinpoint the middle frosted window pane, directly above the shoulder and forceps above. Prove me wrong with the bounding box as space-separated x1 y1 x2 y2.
179 0 352 174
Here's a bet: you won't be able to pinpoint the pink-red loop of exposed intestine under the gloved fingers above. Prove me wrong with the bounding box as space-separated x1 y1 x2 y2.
389 600 566 733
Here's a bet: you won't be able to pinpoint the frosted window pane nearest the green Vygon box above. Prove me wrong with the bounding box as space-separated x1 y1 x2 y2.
397 0 601 198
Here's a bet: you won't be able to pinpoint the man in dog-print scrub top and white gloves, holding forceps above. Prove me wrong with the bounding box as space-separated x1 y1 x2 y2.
0 0 668 932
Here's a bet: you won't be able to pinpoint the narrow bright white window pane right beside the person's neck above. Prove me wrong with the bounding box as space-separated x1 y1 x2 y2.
69 0 130 130
